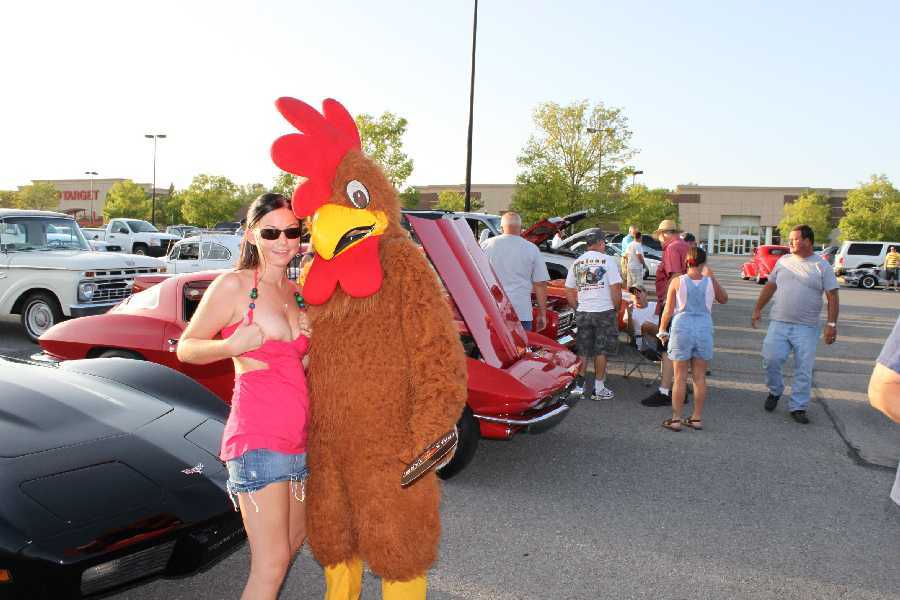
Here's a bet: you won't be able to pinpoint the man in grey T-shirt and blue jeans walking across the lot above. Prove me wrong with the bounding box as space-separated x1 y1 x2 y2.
751 225 838 424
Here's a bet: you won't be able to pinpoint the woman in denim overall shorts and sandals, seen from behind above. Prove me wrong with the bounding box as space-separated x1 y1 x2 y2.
657 246 728 431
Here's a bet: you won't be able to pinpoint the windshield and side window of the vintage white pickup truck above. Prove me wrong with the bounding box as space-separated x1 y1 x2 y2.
0 217 90 252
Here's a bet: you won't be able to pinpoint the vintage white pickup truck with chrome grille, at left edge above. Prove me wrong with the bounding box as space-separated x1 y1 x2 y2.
0 208 166 341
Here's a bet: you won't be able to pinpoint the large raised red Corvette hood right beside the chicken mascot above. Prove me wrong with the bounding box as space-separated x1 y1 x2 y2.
406 213 527 368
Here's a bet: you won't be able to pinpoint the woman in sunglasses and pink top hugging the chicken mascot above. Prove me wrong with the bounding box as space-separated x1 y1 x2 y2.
178 194 310 599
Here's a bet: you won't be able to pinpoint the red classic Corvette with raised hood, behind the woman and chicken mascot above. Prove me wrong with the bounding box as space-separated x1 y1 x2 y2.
39 213 580 478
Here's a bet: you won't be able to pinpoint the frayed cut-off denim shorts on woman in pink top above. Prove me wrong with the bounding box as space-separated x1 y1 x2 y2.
225 448 309 512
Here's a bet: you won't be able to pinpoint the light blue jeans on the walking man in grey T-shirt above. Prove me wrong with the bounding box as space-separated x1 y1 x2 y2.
763 321 820 411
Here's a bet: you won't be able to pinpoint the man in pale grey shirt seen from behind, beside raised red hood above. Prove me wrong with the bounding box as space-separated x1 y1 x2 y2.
481 212 550 331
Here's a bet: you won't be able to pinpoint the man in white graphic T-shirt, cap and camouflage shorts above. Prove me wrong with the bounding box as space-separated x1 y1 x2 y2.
566 228 622 400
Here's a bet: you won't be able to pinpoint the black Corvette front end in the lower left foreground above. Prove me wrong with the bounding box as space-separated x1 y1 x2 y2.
0 357 246 600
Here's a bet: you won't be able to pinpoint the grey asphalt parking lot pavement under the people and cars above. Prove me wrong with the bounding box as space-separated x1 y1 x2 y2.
0 257 900 600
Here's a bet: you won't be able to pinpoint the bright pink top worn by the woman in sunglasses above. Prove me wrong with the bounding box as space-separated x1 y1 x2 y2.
220 274 309 461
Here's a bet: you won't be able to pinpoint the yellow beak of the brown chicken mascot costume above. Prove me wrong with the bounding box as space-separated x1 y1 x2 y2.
312 204 388 260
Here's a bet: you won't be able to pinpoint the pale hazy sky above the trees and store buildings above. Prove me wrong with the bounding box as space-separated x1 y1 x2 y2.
0 0 900 189
